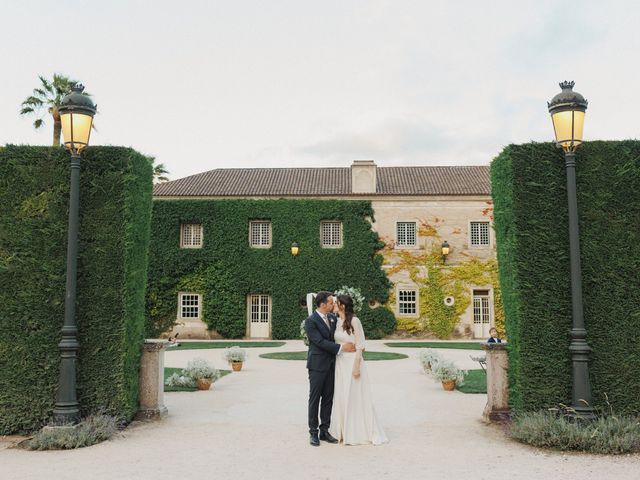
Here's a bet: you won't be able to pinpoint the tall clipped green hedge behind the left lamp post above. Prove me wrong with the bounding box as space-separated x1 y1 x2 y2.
0 146 152 434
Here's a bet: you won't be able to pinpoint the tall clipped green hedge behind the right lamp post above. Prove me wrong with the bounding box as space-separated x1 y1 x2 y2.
491 141 640 414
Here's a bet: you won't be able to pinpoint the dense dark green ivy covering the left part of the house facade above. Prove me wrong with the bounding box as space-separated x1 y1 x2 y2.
147 199 395 339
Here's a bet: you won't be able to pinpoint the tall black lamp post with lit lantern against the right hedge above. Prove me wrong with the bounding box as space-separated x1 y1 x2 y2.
547 81 595 419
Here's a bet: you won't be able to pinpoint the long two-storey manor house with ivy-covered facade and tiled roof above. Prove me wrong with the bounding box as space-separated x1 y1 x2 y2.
147 162 504 338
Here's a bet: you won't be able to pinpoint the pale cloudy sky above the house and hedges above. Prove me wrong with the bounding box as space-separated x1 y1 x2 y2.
0 0 640 179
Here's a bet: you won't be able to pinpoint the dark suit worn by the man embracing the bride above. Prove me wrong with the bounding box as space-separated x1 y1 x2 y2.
304 311 340 435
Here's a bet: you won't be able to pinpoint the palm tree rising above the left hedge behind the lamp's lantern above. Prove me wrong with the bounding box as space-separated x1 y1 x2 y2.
20 73 91 147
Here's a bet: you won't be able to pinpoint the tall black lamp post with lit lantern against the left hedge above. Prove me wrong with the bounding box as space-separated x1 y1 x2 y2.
53 84 96 424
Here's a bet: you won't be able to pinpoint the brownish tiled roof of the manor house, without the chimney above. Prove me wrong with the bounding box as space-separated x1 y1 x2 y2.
153 166 491 197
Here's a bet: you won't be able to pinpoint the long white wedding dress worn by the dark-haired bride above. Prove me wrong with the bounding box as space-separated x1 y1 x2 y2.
329 317 388 445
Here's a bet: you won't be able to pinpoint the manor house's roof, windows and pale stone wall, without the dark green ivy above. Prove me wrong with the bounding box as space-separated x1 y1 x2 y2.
154 160 499 338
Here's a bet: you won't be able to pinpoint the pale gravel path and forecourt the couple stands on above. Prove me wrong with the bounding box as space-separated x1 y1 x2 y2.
0 341 640 480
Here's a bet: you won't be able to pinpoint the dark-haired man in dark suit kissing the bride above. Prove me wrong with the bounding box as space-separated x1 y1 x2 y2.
304 292 356 447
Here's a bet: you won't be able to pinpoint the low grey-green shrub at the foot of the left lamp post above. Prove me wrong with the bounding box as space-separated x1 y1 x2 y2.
20 414 117 450
